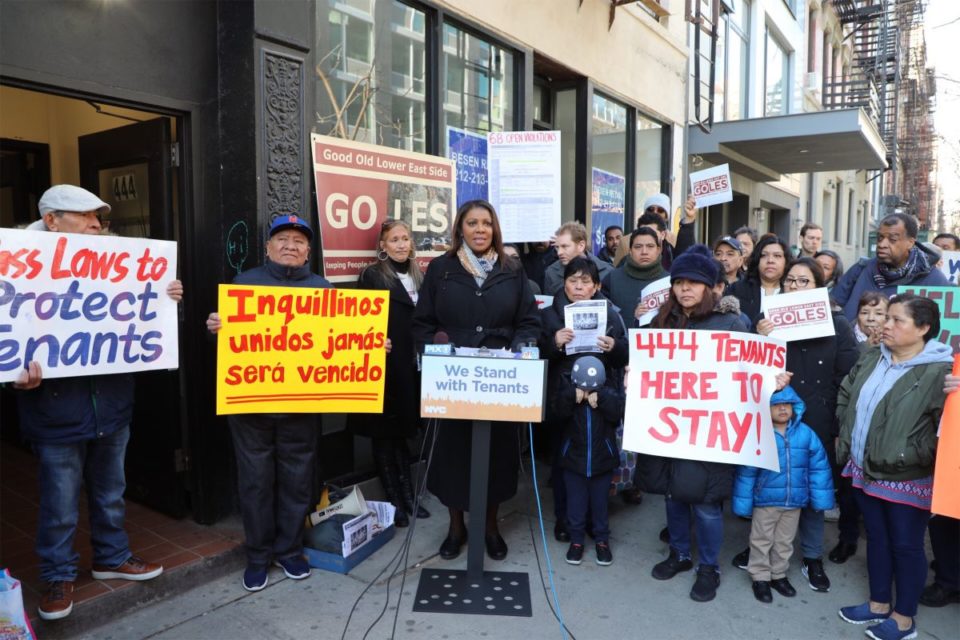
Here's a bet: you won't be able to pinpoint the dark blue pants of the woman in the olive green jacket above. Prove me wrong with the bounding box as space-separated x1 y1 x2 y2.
854 489 930 618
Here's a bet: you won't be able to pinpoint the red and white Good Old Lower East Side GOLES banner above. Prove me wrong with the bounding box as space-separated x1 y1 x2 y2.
310 134 457 282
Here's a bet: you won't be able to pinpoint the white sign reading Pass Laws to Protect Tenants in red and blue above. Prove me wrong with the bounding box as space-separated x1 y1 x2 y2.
0 229 179 382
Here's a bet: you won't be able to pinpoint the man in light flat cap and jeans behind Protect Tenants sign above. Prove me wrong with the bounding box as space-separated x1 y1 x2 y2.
13 184 183 620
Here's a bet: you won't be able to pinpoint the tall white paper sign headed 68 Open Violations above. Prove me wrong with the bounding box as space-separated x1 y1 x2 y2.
487 131 562 242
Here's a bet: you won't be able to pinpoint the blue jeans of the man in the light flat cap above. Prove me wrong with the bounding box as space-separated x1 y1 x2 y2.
33 427 130 582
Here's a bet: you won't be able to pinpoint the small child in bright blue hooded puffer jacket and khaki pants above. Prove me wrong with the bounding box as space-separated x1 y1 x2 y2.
733 387 833 602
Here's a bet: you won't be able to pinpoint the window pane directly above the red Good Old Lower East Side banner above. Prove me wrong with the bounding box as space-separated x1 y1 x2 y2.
314 0 426 151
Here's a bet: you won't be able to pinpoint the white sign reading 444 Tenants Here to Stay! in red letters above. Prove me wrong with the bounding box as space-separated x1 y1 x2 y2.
623 329 787 471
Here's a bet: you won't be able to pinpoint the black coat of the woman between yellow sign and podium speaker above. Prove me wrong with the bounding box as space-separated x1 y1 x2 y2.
348 265 420 438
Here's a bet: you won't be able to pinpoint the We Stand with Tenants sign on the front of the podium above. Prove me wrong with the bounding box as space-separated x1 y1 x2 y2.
420 355 546 422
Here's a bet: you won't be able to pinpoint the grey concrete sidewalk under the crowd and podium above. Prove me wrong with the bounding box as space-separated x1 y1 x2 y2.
80 465 960 640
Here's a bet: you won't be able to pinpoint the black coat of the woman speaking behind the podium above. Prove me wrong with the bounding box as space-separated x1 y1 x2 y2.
413 255 540 511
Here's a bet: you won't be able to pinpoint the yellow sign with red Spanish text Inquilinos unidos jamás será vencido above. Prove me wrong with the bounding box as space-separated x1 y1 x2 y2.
217 285 389 415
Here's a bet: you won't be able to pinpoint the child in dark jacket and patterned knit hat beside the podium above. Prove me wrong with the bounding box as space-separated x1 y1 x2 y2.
555 356 624 566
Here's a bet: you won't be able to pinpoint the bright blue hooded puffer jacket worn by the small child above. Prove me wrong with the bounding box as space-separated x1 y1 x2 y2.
733 387 834 517
